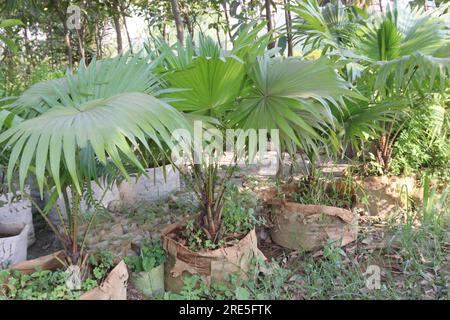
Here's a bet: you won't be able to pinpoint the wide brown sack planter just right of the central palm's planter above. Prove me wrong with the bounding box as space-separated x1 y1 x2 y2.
263 185 358 251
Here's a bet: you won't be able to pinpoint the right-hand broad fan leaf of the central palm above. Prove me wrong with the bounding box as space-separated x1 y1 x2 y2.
229 57 361 156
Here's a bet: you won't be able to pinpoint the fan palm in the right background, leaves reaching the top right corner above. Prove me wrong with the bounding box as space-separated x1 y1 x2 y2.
290 0 450 171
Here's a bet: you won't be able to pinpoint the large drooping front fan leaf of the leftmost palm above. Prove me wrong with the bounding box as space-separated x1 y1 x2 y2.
0 93 189 198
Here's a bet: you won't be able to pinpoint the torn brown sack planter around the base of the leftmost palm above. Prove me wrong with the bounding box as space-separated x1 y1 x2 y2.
11 251 128 300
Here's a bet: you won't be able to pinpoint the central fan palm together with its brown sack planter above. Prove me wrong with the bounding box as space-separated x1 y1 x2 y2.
151 26 353 291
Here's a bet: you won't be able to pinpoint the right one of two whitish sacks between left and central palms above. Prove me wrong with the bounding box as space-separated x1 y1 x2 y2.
119 164 180 206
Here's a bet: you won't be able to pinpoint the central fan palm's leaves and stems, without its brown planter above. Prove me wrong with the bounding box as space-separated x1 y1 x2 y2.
153 24 359 244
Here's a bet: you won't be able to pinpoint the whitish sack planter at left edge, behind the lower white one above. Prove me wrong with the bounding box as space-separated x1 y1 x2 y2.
0 194 36 247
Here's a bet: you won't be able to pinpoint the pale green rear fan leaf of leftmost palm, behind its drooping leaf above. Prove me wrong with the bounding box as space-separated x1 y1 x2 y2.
7 54 159 118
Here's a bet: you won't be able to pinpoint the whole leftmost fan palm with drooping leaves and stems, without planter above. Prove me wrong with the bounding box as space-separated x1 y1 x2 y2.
0 57 189 272
